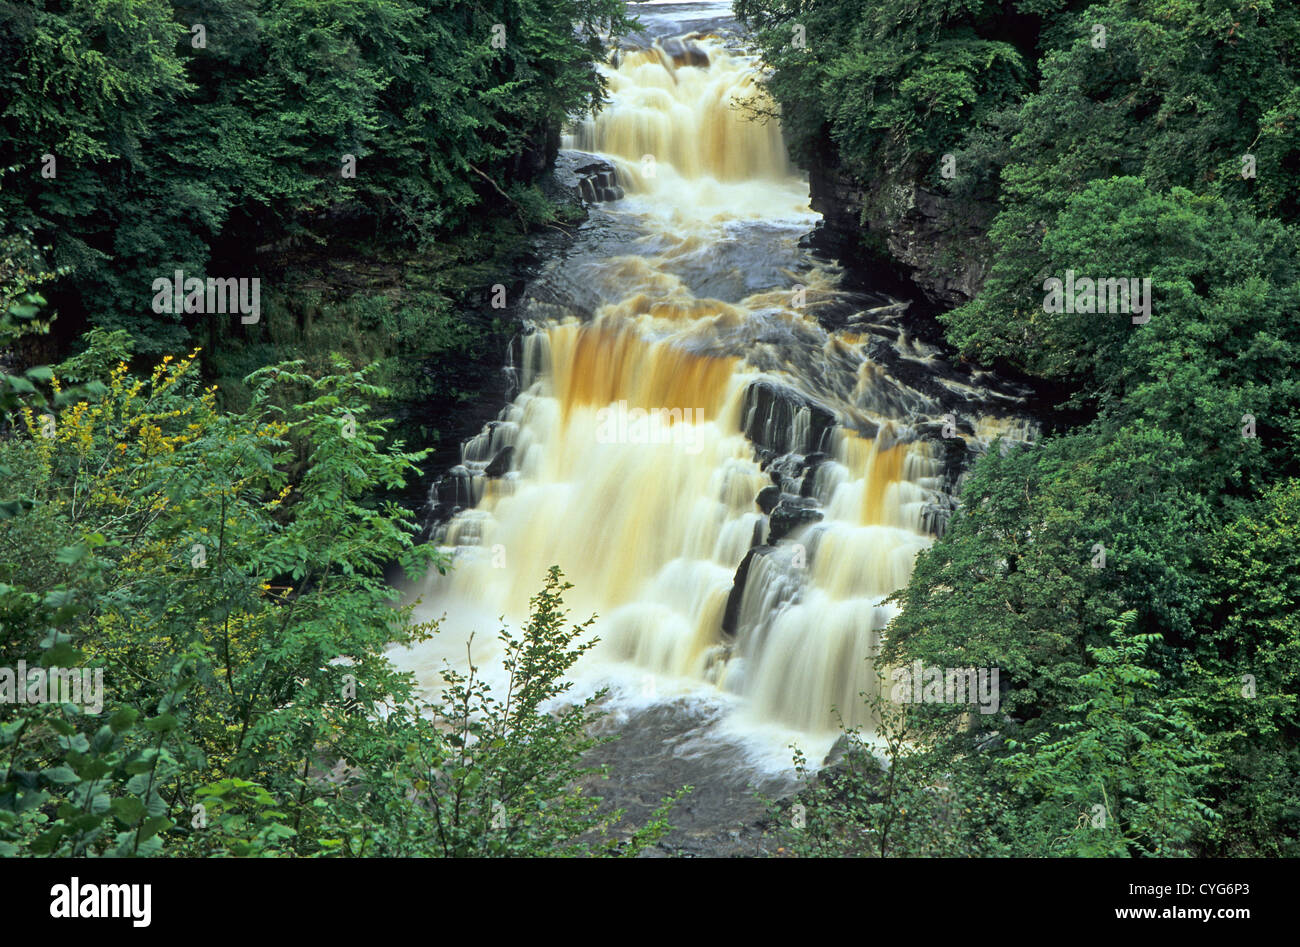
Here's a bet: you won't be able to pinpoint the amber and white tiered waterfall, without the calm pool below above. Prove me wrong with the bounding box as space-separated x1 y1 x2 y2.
400 25 1034 759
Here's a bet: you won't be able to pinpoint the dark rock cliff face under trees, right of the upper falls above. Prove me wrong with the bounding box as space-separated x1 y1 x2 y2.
809 151 995 308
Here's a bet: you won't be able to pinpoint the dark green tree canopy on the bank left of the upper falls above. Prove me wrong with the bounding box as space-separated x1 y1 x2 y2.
0 0 623 354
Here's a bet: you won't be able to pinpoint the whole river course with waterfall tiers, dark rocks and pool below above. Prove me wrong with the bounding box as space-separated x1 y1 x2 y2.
394 4 1034 853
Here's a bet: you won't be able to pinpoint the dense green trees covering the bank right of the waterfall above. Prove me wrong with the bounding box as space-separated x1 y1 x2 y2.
737 0 1300 855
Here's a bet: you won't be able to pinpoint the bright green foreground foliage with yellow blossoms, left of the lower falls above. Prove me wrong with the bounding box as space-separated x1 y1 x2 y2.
0 312 663 856
